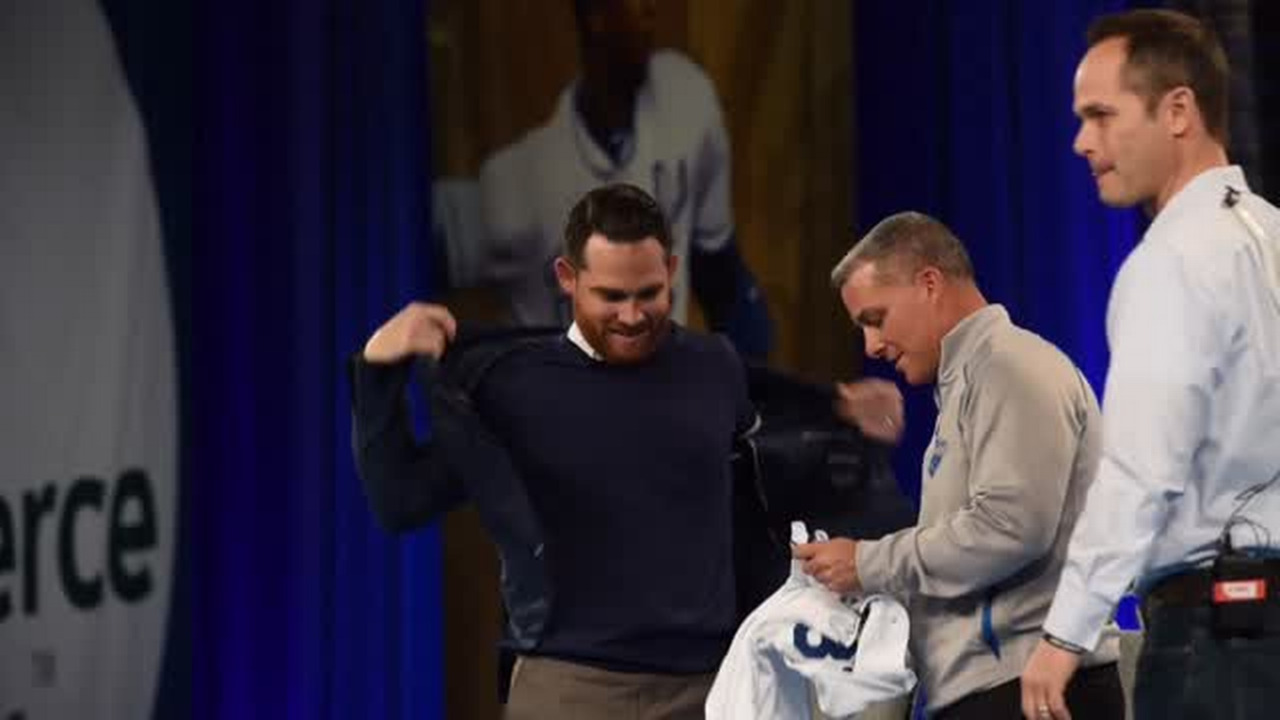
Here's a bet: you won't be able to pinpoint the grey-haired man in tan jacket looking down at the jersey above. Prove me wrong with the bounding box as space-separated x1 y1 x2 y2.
795 213 1124 719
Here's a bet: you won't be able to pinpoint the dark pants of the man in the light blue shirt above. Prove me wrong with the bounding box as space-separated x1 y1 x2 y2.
1133 602 1280 720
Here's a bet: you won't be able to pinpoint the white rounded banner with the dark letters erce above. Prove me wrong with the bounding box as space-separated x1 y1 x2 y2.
0 0 178 720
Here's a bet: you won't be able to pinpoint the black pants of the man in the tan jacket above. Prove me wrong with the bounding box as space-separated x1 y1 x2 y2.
932 662 1124 720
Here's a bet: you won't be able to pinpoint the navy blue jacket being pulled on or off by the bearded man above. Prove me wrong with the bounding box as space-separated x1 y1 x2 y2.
349 328 915 651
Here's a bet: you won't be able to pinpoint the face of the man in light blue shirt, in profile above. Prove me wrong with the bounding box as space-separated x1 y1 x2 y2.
1073 37 1176 208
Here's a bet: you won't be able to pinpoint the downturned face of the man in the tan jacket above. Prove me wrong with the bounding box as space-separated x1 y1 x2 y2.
840 263 943 384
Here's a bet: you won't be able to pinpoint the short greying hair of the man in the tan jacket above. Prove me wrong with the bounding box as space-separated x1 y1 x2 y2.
831 213 973 290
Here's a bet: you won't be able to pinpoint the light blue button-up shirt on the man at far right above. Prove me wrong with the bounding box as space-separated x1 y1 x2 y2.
1044 167 1280 647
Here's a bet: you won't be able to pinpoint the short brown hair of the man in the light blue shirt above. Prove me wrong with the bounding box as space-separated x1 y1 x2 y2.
1087 9 1231 145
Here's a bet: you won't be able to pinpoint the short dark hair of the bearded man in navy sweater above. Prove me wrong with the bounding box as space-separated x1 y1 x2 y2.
564 182 671 268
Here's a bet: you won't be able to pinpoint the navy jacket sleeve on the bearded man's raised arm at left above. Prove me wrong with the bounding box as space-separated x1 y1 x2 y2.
348 354 466 532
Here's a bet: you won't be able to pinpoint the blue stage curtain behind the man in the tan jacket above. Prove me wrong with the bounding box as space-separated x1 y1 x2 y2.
850 0 1142 497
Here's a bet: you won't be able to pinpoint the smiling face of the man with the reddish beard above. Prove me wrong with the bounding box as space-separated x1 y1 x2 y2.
556 233 676 364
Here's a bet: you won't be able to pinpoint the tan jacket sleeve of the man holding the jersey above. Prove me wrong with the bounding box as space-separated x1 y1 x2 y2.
858 356 1084 597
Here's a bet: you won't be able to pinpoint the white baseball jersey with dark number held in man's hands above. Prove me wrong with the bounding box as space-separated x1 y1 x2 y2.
707 523 915 720
